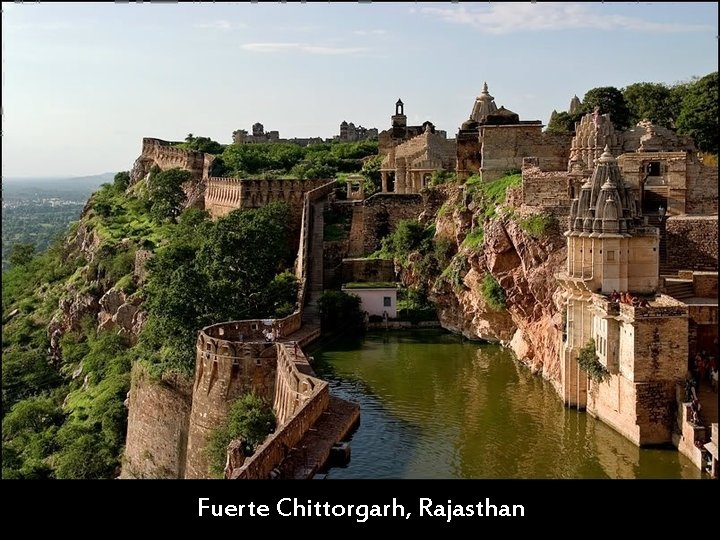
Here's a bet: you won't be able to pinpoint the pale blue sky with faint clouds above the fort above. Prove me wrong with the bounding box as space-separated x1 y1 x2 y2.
2 2 718 176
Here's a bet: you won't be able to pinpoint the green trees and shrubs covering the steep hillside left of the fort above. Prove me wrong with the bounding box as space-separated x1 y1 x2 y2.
2 170 297 478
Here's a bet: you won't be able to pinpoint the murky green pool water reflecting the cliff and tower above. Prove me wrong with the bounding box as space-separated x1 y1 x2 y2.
311 330 700 478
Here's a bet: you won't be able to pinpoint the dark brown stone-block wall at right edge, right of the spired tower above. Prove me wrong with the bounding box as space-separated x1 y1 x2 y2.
666 215 718 271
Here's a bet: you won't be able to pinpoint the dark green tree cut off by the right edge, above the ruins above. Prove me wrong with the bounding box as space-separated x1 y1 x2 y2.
676 71 718 154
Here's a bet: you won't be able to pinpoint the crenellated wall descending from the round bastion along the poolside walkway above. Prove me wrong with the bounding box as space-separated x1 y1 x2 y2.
231 343 330 480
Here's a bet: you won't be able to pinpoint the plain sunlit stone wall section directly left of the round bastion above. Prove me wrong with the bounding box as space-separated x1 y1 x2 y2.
120 362 192 478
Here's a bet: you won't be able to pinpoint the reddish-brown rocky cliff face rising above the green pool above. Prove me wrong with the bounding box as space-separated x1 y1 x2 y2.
422 188 566 385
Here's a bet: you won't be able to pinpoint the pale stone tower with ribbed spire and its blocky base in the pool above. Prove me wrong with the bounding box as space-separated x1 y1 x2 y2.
558 146 687 445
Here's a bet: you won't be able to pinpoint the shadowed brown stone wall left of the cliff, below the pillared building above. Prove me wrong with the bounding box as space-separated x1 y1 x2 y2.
363 193 423 253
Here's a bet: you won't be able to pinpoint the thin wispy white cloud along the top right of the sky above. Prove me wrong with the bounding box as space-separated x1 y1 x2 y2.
420 2 713 34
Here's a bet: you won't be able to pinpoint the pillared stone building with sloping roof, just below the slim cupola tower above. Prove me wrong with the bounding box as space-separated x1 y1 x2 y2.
380 124 455 193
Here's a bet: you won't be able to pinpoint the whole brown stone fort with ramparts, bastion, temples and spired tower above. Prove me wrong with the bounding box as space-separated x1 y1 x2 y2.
125 85 718 478
